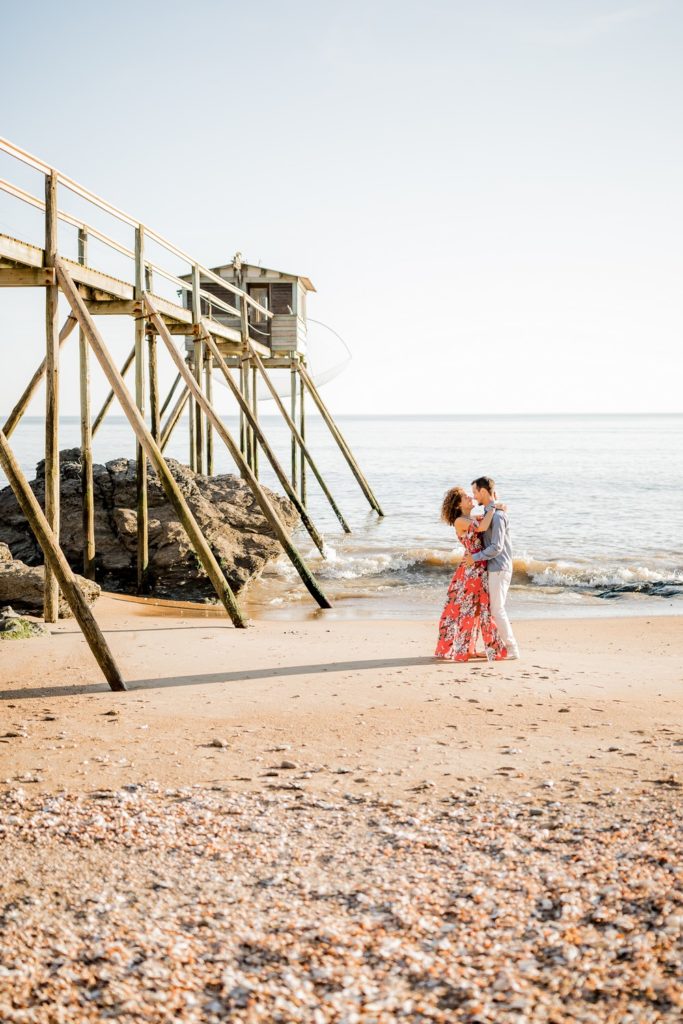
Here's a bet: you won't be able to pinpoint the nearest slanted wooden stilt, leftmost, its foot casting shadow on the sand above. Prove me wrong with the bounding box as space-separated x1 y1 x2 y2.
0 431 126 690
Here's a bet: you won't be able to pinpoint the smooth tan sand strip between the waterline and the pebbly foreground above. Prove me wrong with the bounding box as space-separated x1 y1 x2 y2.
0 598 683 799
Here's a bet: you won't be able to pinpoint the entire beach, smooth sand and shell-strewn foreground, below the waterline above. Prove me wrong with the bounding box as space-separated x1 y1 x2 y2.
0 598 683 1024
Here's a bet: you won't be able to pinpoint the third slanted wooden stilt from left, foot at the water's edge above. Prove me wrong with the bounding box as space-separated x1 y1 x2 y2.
144 295 331 608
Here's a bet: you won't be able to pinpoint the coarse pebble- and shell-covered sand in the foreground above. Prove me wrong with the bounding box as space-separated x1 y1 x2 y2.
0 783 683 1024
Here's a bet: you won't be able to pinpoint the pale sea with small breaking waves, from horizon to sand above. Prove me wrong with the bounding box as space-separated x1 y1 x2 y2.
0 402 683 620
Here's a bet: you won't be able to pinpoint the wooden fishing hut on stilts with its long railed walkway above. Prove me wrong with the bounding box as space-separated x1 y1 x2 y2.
0 138 382 690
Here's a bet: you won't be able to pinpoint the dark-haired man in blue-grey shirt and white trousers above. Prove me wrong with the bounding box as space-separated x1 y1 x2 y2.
465 476 519 658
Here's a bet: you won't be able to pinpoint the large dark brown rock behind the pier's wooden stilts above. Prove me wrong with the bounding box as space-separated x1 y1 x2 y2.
0 449 298 601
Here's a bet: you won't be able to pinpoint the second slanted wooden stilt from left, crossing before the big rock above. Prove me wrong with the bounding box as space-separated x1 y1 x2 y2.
55 257 247 628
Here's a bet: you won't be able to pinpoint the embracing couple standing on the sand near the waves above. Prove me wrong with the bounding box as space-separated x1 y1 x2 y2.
435 476 519 662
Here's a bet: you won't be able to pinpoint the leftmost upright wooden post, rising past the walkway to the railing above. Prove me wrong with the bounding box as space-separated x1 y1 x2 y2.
44 171 59 623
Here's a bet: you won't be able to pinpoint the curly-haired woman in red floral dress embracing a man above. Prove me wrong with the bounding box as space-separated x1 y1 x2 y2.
435 487 508 662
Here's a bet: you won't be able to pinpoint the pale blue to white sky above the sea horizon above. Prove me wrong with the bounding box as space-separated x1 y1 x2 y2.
0 0 683 414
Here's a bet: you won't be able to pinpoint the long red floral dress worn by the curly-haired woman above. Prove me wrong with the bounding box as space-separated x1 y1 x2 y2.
434 523 508 662
